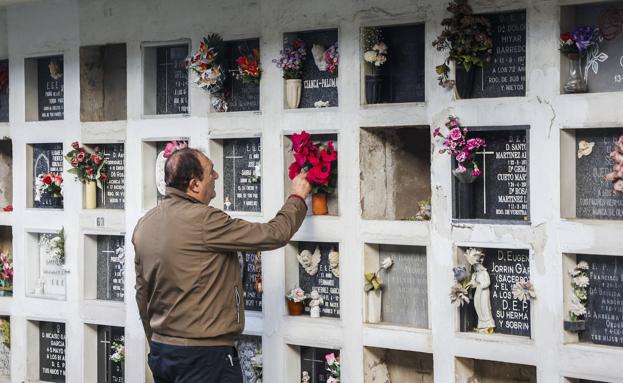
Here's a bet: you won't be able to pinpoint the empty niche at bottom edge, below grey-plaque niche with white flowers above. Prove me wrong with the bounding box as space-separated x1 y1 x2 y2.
363 347 433 383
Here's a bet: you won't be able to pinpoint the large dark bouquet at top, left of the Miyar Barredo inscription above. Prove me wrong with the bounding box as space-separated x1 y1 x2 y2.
433 0 493 89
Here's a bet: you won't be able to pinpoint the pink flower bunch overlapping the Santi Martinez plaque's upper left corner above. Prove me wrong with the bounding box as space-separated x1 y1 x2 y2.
433 116 486 180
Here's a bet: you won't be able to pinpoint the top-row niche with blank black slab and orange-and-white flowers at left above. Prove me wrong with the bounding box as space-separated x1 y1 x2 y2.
361 23 426 104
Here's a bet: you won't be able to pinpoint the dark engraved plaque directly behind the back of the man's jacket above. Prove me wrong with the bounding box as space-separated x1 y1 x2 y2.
97 235 125 302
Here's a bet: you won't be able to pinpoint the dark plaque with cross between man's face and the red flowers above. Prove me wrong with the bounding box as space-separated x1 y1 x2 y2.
223 138 262 212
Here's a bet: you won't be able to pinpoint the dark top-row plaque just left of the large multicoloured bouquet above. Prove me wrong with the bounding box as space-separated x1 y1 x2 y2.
156 44 188 114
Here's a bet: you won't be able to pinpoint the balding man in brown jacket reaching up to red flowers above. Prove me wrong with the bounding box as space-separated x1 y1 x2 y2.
132 148 310 383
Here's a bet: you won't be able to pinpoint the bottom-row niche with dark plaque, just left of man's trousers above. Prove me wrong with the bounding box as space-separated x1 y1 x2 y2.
83 324 125 383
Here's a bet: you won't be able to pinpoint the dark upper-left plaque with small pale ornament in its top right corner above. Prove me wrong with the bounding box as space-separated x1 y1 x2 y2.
37 56 65 121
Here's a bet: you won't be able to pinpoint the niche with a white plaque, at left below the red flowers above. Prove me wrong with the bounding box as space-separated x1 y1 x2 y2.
26 230 67 300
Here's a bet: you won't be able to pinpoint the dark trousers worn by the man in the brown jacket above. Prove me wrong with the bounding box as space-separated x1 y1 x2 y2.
148 342 242 383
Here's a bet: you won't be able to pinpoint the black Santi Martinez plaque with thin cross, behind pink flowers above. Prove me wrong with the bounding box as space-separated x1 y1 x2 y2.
452 126 530 224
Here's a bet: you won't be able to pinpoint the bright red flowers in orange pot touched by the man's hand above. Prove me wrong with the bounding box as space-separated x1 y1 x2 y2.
288 131 337 215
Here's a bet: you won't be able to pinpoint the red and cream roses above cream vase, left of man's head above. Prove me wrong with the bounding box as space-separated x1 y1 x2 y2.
65 141 108 189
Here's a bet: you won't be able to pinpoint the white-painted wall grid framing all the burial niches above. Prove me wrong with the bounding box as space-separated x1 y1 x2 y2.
0 0 623 383
